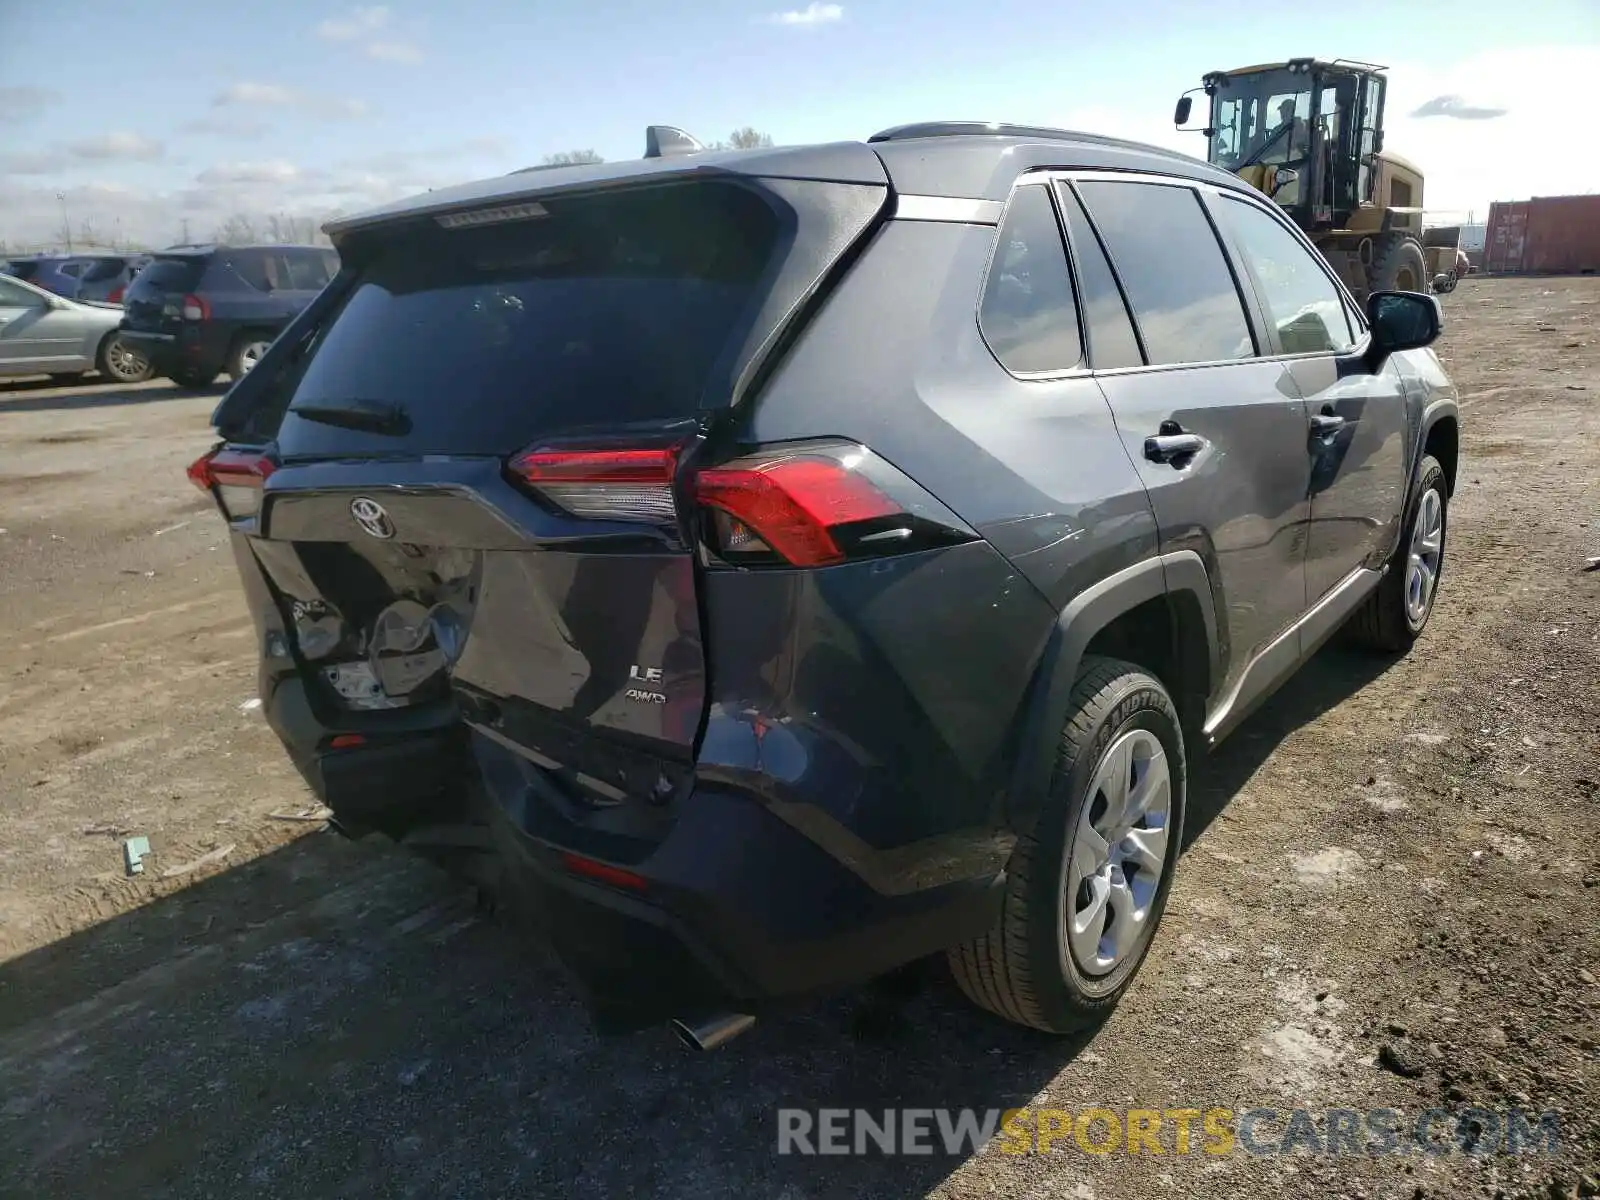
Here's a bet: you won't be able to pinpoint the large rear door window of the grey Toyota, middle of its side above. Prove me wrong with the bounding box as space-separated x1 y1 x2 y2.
1078 182 1256 365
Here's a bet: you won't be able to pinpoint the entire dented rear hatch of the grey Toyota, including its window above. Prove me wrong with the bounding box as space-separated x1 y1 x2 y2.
203 160 886 805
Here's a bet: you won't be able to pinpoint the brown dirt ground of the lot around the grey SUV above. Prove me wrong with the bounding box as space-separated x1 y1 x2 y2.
0 278 1600 1200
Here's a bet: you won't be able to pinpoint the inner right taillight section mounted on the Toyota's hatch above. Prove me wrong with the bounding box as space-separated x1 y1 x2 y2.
510 445 682 525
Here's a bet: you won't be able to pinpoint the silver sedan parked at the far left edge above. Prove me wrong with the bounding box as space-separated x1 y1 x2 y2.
0 275 150 384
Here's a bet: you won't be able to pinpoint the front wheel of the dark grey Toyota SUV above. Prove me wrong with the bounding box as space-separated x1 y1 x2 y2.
1349 454 1450 654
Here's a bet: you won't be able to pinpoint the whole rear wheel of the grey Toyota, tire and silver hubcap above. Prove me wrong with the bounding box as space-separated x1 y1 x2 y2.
949 658 1186 1034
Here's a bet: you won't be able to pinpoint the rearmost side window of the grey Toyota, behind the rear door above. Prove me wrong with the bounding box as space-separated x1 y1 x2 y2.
978 184 1083 374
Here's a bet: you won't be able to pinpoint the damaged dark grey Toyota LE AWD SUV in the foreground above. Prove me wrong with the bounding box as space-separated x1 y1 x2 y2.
190 125 1458 1043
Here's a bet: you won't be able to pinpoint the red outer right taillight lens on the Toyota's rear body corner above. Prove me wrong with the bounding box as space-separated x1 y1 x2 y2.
694 454 902 566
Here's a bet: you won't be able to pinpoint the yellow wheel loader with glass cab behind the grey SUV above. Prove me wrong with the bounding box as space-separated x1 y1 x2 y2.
1173 58 1461 301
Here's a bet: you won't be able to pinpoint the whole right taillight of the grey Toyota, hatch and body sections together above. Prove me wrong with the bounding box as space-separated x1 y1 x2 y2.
509 438 978 566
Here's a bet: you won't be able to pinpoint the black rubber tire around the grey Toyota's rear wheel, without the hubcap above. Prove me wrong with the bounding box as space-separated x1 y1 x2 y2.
947 658 1186 1034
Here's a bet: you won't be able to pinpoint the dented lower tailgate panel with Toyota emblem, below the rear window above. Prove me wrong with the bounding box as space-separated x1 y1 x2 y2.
250 458 704 795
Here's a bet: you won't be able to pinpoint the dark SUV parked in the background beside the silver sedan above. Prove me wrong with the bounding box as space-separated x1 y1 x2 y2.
122 245 339 387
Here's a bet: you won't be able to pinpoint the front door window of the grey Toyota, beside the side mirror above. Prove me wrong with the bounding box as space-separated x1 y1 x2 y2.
1222 197 1352 354
